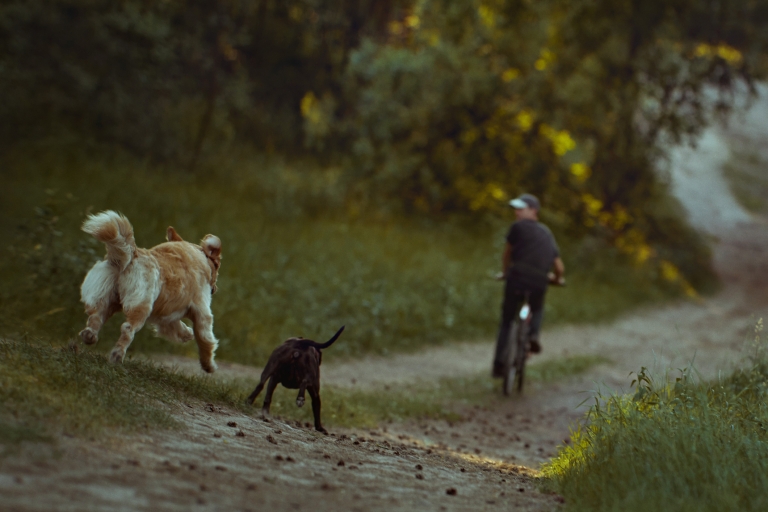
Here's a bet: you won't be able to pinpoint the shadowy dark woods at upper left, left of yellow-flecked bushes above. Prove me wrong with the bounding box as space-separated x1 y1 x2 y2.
0 0 404 161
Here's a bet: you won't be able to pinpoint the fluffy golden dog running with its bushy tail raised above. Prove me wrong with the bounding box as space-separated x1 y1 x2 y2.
80 211 221 373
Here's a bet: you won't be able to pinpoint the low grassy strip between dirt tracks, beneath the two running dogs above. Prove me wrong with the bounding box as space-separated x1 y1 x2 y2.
0 340 603 454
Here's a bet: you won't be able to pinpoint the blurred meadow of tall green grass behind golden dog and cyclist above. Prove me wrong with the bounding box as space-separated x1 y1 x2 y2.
0 141 680 364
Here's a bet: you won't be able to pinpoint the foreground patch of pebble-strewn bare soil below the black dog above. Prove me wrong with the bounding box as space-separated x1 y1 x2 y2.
0 403 560 511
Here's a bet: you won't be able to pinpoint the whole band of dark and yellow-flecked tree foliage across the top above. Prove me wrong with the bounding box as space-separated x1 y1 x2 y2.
0 0 768 291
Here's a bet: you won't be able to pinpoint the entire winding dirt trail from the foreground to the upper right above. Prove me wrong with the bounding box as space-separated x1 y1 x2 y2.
0 90 768 511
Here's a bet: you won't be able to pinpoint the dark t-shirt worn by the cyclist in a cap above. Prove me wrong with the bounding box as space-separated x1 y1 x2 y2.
507 219 560 290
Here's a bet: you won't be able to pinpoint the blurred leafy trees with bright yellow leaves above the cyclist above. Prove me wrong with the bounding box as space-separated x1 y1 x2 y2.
322 0 768 293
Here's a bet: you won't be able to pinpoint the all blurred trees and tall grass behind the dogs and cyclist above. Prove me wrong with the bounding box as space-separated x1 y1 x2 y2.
0 0 768 363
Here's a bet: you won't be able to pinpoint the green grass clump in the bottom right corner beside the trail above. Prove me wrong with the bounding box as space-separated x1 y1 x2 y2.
543 322 768 512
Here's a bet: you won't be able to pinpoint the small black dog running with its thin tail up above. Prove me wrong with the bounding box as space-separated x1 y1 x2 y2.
248 326 344 434
